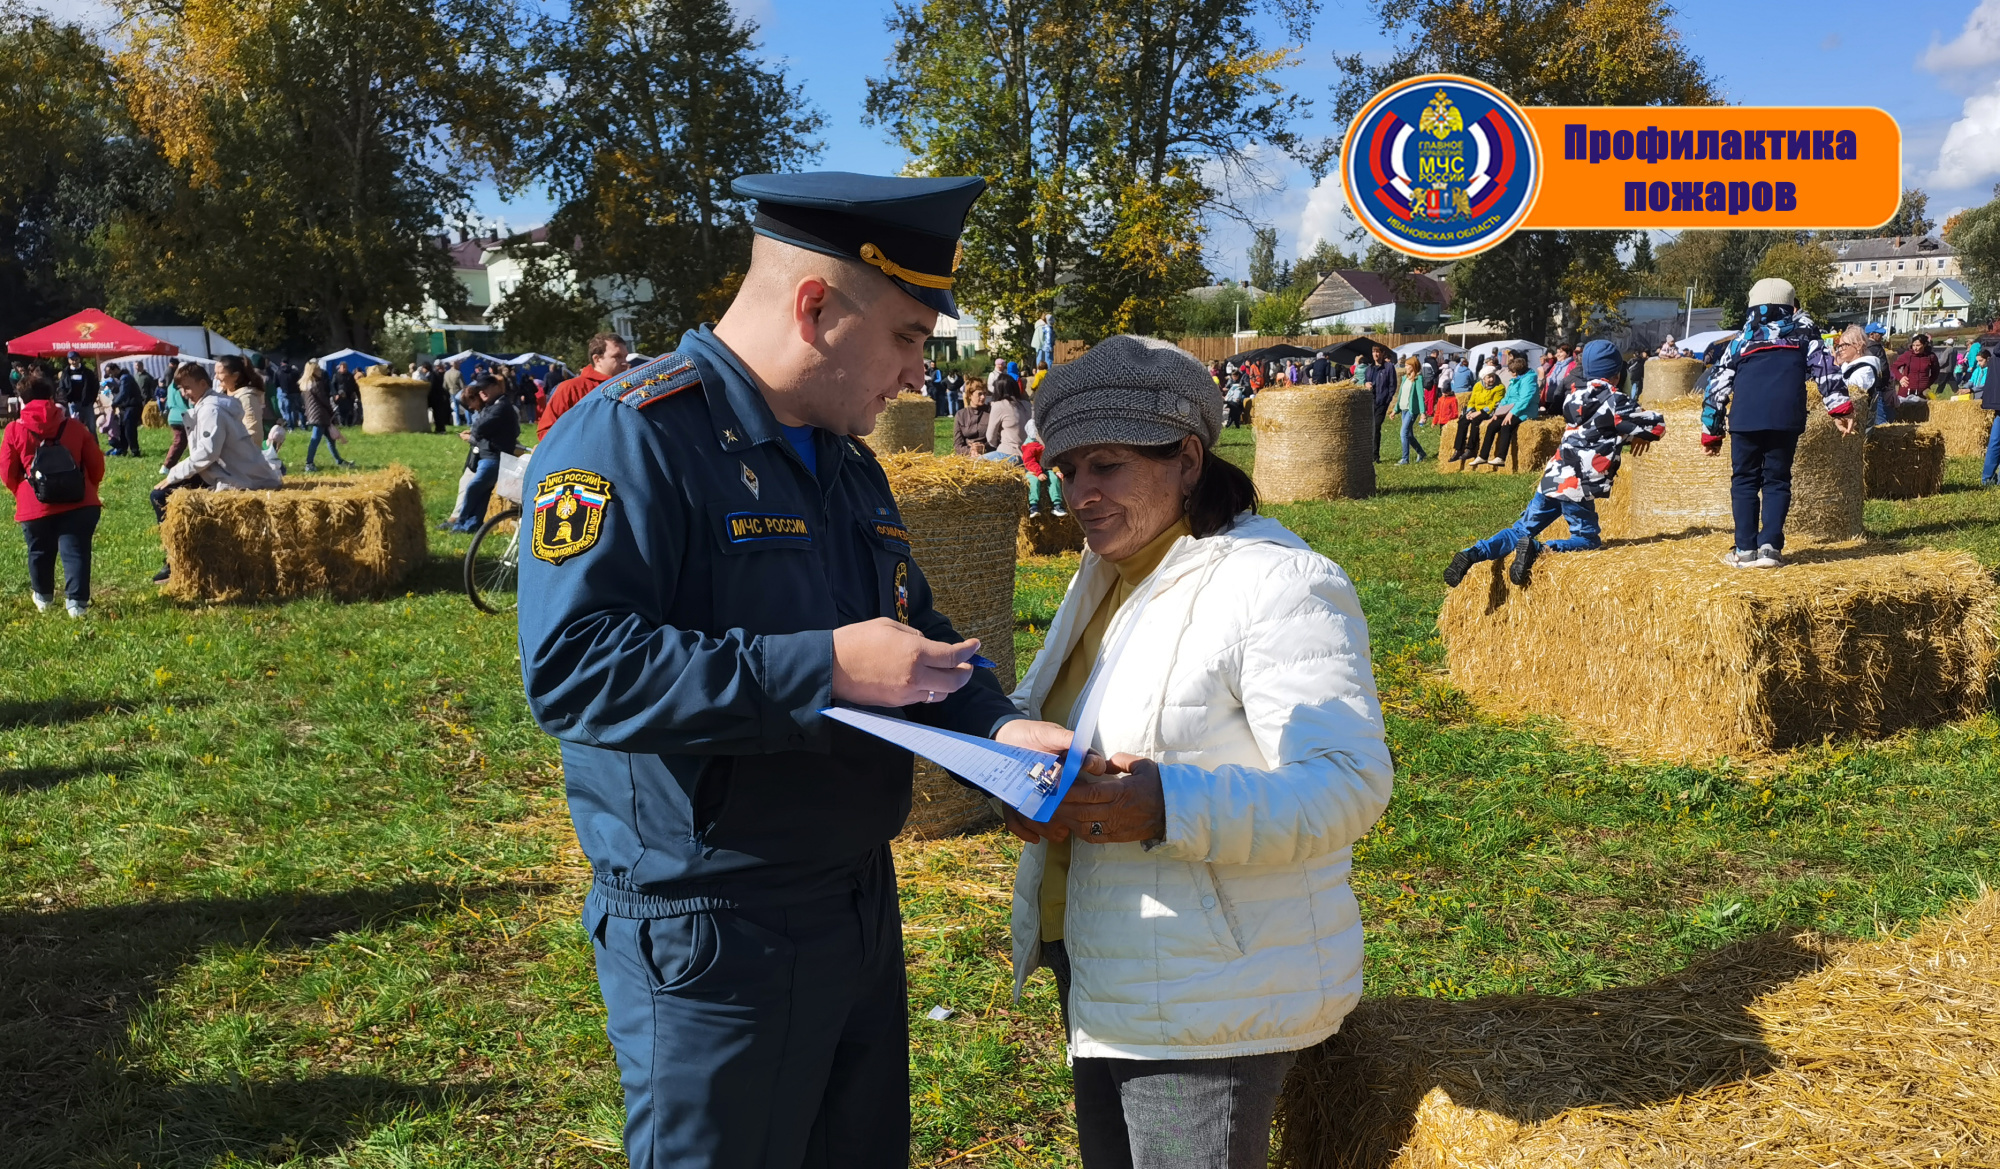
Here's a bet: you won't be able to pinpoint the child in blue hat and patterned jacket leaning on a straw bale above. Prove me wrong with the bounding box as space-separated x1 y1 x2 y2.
1444 340 1666 589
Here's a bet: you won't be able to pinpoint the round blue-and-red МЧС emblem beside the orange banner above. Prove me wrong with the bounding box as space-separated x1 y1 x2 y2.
1340 74 1542 260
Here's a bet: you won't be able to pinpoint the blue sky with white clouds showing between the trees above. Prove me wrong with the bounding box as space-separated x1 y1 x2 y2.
42 0 2000 276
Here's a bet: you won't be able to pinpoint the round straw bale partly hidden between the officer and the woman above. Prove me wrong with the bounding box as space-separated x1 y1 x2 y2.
882 450 1028 841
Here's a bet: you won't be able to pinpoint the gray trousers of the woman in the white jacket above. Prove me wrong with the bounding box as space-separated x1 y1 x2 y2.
1042 941 1298 1169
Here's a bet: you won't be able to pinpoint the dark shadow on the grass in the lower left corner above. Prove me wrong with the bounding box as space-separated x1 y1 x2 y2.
0 885 506 1165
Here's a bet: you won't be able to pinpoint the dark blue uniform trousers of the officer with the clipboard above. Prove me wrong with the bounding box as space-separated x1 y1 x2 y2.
584 845 910 1169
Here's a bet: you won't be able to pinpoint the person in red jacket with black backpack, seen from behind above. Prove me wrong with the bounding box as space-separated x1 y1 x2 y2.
0 368 104 617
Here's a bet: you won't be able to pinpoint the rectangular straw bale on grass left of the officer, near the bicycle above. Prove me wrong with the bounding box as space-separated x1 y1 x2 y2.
160 466 430 601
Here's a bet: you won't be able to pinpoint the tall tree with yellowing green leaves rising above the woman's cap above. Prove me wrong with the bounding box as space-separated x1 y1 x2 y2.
868 0 1314 346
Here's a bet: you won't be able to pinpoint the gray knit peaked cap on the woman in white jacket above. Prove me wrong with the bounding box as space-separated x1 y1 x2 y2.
1034 334 1222 462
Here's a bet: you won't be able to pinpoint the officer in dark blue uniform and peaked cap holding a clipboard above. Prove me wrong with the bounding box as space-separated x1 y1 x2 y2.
520 172 1070 1169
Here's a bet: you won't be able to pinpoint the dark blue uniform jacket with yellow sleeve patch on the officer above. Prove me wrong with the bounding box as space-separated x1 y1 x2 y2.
520 326 1020 897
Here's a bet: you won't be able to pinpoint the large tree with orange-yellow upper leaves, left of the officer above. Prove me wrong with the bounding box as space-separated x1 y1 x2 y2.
106 0 534 348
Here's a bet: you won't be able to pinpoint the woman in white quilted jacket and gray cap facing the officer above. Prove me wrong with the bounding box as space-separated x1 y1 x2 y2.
1008 336 1392 1169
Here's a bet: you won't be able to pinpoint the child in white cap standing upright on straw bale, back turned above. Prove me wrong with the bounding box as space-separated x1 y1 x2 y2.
1702 278 1854 568
